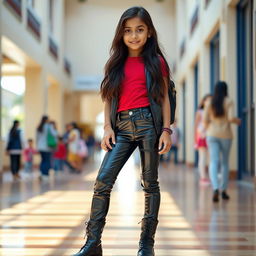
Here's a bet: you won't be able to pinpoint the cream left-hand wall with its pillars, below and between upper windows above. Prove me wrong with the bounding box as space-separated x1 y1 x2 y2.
0 0 73 169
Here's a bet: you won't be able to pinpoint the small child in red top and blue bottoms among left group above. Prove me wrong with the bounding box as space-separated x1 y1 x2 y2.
53 137 67 171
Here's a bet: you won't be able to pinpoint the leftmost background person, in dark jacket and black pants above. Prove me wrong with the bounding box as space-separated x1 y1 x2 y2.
6 120 24 180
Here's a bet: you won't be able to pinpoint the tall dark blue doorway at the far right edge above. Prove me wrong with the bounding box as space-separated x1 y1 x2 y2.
237 0 255 180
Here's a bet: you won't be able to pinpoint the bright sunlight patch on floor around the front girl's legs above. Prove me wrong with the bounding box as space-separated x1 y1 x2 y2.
0 164 210 256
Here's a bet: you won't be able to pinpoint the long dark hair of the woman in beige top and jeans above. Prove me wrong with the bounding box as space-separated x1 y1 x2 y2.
211 81 228 117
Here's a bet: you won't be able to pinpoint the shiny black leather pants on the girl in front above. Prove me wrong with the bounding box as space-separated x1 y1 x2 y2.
90 107 160 221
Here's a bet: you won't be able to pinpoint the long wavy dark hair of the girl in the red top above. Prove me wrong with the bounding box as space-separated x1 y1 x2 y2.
100 6 170 102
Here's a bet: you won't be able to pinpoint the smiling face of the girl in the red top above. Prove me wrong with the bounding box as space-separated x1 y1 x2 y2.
123 17 150 57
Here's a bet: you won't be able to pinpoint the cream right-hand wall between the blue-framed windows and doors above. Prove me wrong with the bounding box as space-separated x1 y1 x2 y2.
175 0 242 170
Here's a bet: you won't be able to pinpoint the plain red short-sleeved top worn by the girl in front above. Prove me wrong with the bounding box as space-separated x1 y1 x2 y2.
117 57 168 112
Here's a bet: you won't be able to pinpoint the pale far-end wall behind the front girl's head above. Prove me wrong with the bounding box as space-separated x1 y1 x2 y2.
65 0 176 82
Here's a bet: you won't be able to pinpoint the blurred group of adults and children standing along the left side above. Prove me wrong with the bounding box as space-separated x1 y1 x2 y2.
6 115 93 180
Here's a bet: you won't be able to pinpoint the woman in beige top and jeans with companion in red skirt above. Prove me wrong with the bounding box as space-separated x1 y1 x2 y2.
195 81 241 202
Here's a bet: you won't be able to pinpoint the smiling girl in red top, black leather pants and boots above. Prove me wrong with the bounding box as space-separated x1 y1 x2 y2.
75 7 171 256
